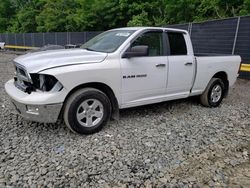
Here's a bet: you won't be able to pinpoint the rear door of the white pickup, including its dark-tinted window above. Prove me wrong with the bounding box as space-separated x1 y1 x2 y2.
166 31 195 97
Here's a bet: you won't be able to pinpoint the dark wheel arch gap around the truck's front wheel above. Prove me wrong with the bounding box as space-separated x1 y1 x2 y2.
63 82 119 120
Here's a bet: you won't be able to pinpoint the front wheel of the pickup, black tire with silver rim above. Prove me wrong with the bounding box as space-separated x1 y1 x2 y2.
64 88 111 134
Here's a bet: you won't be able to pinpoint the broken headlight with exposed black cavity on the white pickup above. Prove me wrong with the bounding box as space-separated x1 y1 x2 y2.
30 74 63 92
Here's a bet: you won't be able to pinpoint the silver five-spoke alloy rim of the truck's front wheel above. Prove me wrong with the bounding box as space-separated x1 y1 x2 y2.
76 99 104 127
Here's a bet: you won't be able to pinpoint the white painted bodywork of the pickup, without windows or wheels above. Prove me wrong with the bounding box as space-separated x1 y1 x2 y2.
5 27 241 114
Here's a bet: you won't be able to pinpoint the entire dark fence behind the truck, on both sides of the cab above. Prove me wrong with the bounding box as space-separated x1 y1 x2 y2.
0 16 250 79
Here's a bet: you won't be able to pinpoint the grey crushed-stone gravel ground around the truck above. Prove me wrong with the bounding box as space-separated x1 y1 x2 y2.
0 52 250 188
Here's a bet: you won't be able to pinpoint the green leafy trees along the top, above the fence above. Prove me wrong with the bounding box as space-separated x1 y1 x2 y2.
0 0 250 33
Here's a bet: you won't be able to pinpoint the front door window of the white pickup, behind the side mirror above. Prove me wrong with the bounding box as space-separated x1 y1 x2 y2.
131 32 163 56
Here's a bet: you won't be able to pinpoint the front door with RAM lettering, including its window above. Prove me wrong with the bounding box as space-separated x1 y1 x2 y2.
121 30 168 107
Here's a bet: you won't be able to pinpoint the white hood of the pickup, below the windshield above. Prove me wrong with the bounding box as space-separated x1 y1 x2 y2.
14 49 107 73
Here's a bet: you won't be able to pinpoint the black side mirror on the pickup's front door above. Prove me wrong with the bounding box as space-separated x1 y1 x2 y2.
122 45 148 58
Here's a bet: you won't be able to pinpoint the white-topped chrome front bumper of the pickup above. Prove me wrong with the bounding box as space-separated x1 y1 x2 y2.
5 80 66 123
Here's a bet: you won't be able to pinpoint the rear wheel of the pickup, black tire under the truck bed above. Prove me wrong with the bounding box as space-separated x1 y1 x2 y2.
200 78 225 107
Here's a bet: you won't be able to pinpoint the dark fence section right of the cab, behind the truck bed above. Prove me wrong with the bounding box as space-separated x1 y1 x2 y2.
167 16 250 79
